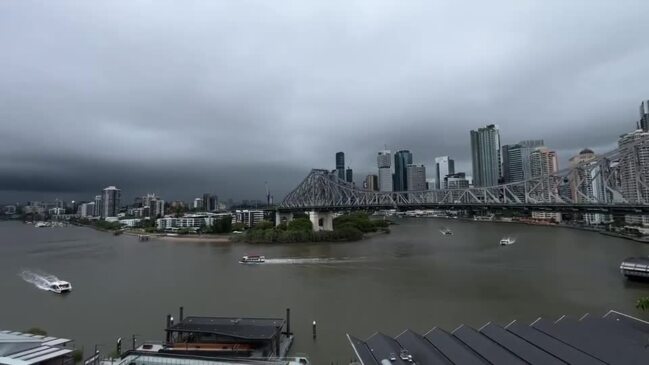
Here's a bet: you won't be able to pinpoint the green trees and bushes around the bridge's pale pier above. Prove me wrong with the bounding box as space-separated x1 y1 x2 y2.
232 212 391 243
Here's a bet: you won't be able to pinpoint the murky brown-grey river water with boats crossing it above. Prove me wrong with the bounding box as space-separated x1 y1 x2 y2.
0 218 649 364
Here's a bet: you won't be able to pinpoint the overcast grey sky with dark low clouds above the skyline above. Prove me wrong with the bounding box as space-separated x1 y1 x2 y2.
0 0 649 202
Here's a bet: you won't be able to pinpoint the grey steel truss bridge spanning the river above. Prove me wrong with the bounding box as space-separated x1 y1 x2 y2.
277 138 649 214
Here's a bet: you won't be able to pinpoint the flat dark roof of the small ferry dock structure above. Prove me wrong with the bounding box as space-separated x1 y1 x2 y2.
166 317 285 340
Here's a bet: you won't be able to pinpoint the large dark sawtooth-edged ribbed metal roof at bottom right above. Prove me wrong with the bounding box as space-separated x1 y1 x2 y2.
348 311 649 365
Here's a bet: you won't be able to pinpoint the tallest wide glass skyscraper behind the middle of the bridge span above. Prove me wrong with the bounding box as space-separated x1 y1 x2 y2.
471 124 502 186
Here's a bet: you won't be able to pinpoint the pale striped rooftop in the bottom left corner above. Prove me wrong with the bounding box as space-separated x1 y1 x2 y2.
0 331 72 365
